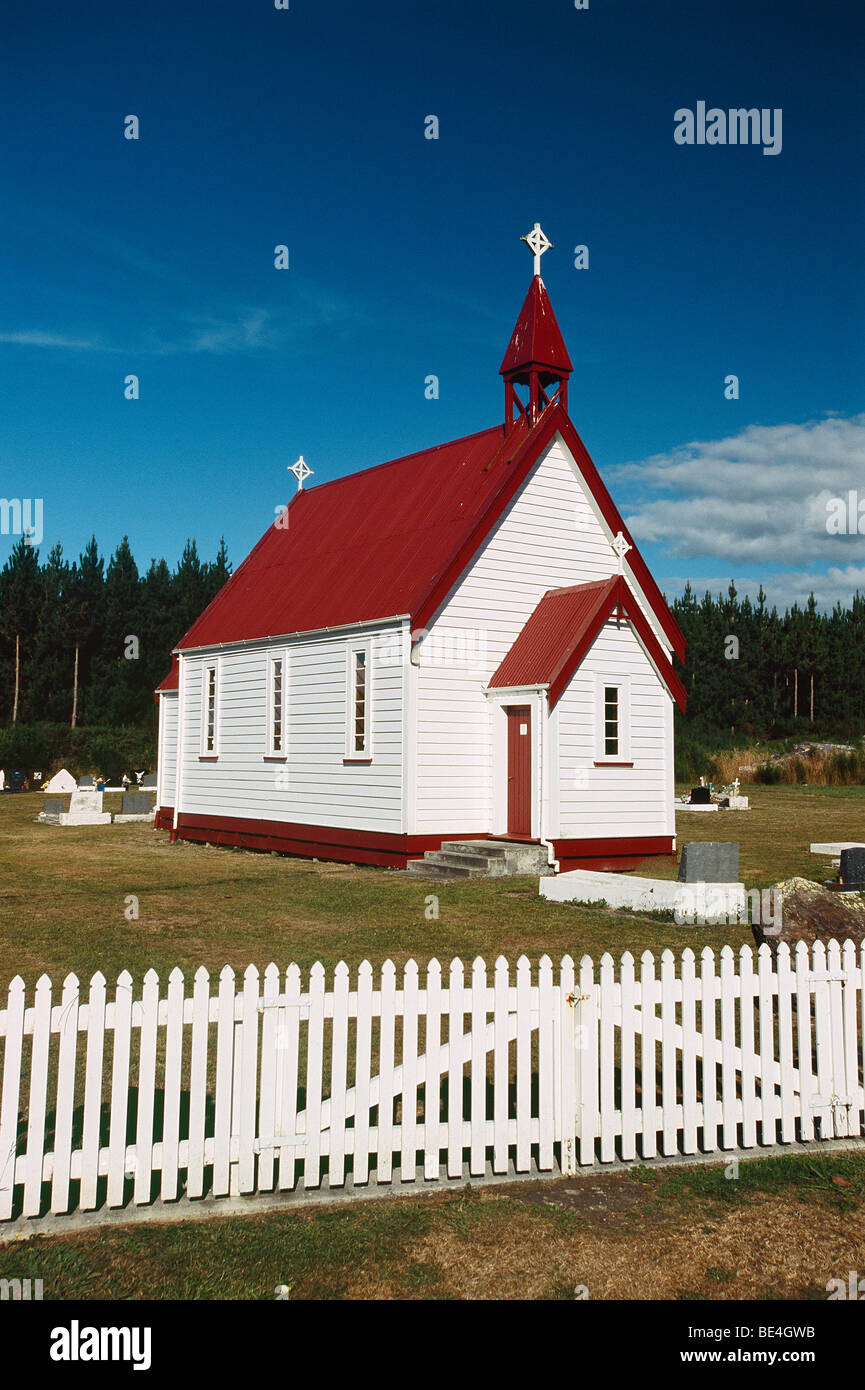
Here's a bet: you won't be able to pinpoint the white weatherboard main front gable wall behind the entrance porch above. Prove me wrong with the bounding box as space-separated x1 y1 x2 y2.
409 436 672 834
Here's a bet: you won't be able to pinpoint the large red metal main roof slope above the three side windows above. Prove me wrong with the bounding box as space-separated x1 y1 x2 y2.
178 425 528 649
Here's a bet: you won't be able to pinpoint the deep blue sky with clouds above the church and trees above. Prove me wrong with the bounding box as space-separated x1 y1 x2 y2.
0 0 865 603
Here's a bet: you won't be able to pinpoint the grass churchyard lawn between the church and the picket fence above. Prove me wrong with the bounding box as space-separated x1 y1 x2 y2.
0 787 865 990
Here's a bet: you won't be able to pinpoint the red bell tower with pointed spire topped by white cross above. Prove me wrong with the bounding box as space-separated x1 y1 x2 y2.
499 222 573 431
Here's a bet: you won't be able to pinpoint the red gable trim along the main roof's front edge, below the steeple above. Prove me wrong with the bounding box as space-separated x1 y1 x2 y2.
412 403 684 660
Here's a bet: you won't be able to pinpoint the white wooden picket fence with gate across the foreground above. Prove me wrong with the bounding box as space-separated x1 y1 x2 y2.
0 942 865 1219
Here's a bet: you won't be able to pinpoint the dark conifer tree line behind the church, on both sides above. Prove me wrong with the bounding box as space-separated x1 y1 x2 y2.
0 537 865 739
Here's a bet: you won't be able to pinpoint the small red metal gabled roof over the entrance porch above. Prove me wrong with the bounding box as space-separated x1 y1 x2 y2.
490 574 687 710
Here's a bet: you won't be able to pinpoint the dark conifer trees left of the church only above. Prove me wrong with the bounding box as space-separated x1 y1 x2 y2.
0 537 231 728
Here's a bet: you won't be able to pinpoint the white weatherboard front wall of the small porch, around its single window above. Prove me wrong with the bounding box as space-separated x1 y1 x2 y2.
553 620 676 840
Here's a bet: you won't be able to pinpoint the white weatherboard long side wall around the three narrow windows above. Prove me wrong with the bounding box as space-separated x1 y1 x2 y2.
181 628 403 833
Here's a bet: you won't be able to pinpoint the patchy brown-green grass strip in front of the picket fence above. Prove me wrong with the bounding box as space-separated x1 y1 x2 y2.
0 1154 865 1300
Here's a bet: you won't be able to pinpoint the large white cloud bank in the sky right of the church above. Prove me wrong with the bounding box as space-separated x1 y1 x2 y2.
611 414 865 574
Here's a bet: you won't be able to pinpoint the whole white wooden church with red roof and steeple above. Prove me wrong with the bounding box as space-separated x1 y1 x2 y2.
156 232 684 870
